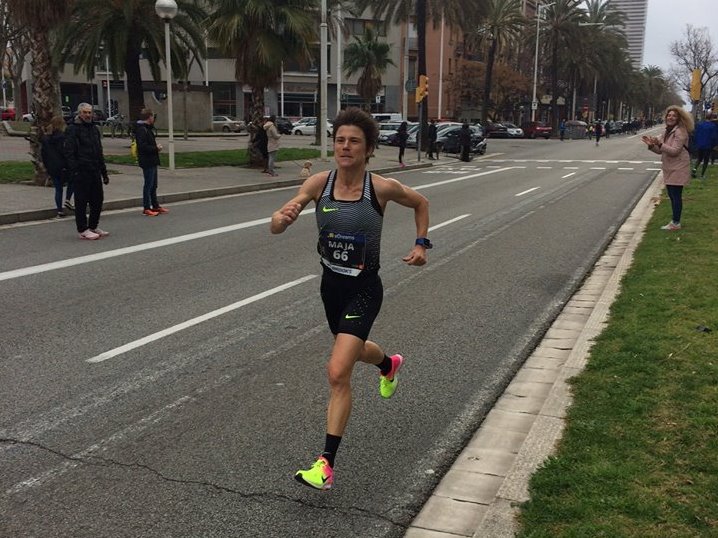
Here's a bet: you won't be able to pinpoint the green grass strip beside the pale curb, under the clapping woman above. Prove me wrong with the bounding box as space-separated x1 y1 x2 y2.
519 169 718 538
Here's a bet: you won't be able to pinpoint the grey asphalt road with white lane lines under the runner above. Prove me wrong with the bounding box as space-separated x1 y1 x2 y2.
0 132 658 537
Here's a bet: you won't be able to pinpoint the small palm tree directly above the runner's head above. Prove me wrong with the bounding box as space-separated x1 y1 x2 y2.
344 28 394 110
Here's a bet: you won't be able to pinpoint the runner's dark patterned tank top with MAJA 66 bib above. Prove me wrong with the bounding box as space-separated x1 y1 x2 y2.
316 170 384 276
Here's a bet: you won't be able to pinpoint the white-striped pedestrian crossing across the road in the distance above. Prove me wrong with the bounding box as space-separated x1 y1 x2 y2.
421 159 661 175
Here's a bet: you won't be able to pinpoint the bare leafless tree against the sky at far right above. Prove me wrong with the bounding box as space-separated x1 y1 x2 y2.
671 24 718 105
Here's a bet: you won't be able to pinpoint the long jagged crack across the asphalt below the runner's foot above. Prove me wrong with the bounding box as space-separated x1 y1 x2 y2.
0 437 409 530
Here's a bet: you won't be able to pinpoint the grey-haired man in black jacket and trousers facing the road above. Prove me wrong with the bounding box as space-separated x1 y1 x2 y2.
64 103 110 239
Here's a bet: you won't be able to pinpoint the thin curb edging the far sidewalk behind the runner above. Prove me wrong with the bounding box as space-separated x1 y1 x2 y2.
0 163 433 226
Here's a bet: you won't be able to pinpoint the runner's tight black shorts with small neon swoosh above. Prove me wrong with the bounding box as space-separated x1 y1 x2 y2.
321 267 384 341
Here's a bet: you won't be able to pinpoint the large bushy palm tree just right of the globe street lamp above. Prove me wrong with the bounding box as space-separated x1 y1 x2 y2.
207 0 318 125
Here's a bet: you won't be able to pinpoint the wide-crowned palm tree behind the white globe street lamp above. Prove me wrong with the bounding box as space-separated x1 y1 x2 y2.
62 0 207 121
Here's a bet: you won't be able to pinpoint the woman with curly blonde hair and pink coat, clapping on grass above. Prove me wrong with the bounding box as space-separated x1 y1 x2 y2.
641 105 693 230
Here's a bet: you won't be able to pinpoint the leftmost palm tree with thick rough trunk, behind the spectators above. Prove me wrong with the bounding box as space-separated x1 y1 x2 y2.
3 0 73 185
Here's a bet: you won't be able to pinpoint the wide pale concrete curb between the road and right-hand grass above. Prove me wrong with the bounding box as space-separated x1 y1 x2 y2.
405 173 663 538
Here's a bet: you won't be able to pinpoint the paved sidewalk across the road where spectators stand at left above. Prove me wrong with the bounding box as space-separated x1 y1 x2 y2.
0 142 432 225
